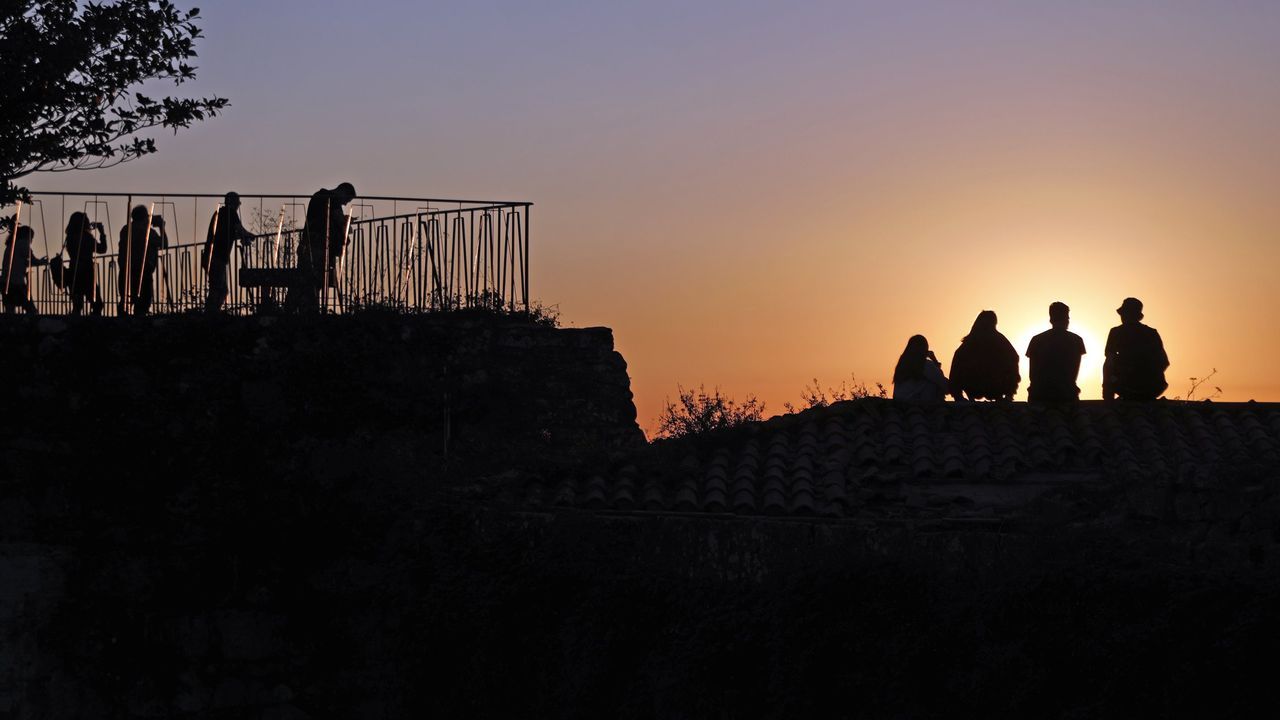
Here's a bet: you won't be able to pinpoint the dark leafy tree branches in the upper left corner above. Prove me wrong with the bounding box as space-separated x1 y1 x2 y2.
0 0 227 204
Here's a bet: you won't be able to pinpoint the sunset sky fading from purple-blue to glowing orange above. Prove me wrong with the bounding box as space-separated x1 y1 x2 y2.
29 0 1280 430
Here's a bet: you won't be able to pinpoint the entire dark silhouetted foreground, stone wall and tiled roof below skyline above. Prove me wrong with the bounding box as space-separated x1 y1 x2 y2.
0 315 1280 719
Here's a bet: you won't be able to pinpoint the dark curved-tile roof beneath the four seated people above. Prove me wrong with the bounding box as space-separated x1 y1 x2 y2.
524 400 1280 518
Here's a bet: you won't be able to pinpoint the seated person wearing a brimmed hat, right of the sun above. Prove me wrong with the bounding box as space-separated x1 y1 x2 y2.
1102 297 1169 400
